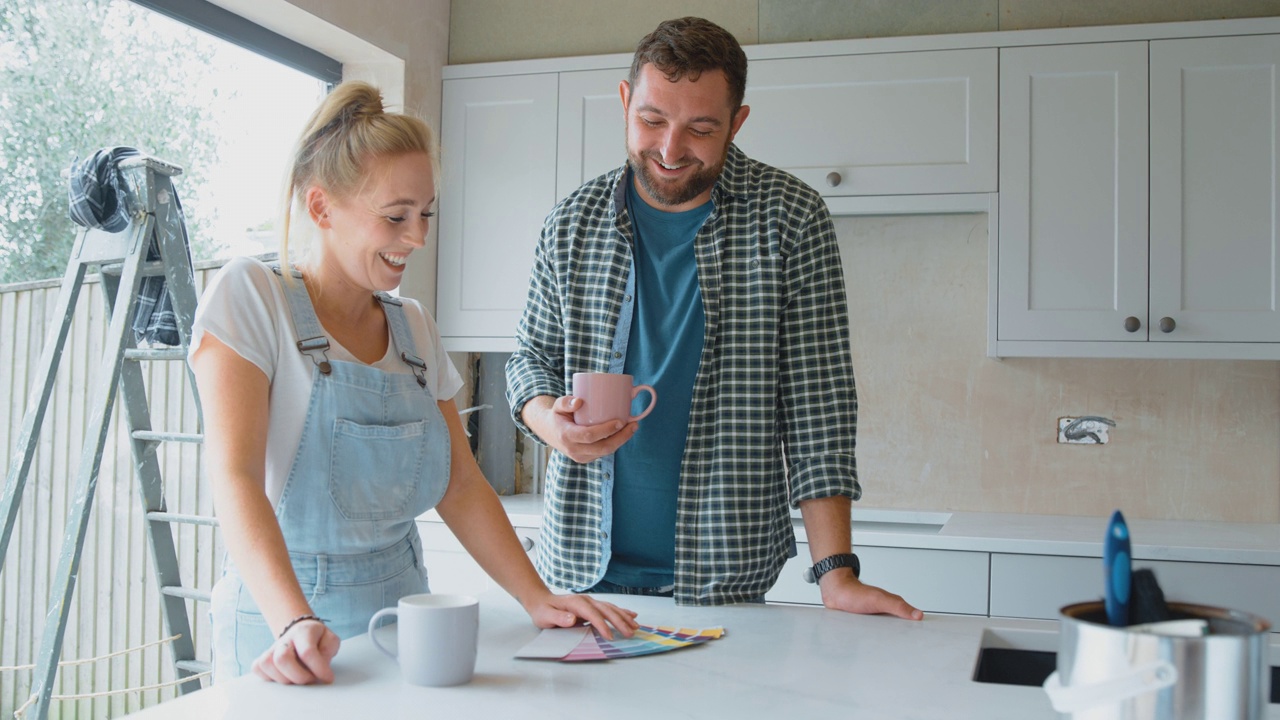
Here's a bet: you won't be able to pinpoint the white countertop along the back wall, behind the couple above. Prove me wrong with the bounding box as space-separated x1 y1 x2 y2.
420 495 1280 565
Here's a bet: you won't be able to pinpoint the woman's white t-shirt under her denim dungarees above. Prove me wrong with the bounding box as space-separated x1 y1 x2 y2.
187 258 462 506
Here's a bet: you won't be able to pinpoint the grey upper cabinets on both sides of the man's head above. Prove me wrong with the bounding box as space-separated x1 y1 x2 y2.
436 47 997 352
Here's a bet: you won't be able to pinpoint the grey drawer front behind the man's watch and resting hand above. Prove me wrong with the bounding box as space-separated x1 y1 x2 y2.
764 543 988 615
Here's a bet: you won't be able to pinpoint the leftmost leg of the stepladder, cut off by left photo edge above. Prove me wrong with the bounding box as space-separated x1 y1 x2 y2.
0 235 88 570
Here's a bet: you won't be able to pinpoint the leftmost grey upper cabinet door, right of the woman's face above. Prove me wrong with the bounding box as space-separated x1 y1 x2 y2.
436 73 557 350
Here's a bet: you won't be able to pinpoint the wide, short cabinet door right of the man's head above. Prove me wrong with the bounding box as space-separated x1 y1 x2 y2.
737 49 996 196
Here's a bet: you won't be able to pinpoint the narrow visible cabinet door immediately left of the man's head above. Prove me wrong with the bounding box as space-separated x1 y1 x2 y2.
556 68 627 199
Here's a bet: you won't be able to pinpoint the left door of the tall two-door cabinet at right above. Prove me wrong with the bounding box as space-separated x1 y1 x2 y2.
997 42 1147 341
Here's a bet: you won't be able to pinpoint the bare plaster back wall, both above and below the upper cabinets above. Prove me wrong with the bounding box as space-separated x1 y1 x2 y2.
449 0 1280 515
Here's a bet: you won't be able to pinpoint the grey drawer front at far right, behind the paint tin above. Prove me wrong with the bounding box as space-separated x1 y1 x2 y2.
991 553 1280 624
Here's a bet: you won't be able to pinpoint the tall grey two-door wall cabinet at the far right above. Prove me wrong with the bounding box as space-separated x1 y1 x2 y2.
995 36 1280 357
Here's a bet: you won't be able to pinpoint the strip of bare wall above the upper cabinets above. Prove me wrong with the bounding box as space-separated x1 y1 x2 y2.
449 0 1280 65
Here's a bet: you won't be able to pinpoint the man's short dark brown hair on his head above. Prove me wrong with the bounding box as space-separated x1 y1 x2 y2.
627 18 746 113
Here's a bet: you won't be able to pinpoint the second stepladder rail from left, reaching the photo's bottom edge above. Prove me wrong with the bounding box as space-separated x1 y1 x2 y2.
32 214 155 720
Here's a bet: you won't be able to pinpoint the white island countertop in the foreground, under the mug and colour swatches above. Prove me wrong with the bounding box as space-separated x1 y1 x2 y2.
124 592 1264 720
